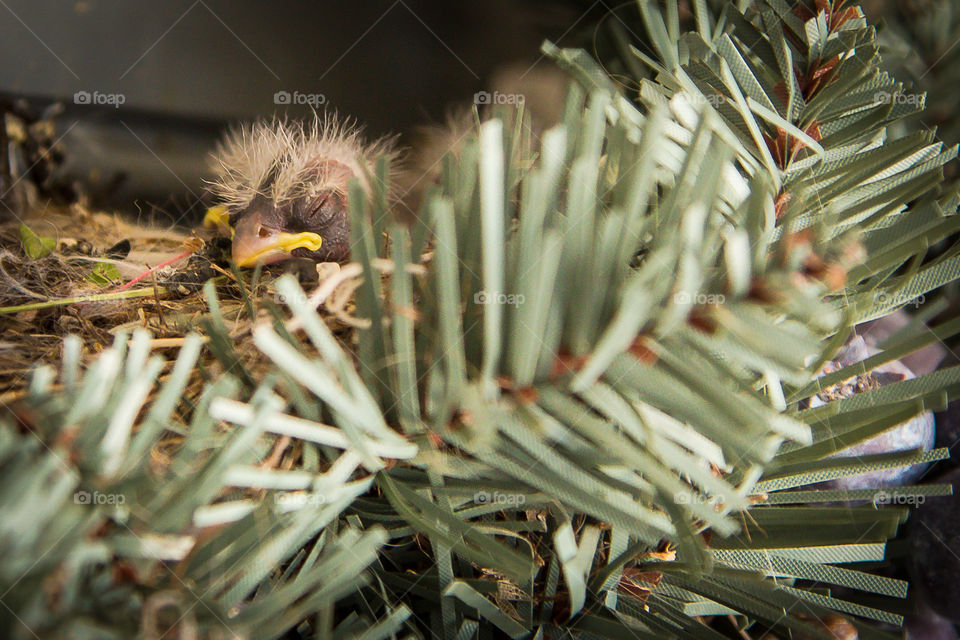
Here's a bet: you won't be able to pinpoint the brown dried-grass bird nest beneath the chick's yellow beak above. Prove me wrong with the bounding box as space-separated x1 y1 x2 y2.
0 205 378 403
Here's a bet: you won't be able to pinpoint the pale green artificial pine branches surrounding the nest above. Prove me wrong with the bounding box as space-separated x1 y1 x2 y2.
0 0 960 638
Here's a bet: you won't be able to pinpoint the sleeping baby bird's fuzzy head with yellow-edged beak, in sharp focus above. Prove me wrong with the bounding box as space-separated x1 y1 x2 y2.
210 114 399 267
